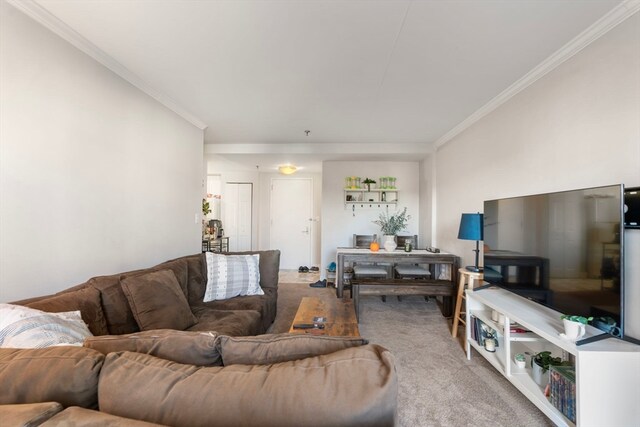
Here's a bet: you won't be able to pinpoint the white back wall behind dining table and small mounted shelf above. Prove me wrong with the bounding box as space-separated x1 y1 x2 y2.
320 161 424 278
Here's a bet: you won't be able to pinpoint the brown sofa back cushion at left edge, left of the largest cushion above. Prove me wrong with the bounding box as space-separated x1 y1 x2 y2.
0 346 104 408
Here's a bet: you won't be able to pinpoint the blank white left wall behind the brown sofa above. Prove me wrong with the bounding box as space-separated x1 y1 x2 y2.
0 2 203 301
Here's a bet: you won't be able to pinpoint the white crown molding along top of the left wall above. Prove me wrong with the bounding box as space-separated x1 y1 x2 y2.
7 0 207 130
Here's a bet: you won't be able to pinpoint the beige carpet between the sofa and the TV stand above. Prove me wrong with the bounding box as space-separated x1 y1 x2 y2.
270 283 553 427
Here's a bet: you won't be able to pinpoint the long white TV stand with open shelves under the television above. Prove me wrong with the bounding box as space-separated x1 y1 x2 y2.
466 287 640 427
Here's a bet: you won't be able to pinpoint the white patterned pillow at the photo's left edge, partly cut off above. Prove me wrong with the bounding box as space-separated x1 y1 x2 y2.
0 304 93 348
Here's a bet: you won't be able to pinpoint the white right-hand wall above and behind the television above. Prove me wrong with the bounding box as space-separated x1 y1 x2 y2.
436 14 640 335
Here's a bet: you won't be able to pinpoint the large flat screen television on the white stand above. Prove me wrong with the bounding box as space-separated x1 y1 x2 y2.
483 185 624 337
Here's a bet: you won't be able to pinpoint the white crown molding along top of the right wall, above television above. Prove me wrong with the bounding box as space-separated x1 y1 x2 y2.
434 0 640 150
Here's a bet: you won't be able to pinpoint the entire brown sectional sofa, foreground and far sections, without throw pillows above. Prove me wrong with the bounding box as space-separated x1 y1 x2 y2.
0 251 397 427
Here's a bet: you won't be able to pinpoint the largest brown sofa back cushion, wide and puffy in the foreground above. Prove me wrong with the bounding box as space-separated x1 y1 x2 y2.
98 345 397 427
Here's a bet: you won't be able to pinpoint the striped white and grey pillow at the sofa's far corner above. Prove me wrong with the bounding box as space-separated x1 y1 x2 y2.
204 252 264 302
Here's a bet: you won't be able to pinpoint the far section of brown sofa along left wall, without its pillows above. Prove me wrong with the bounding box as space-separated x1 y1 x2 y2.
15 250 280 336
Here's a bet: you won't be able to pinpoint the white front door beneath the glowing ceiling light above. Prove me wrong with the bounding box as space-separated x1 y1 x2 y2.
269 178 313 270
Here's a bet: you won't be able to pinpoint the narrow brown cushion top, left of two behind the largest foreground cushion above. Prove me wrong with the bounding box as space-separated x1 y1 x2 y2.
84 329 222 366
